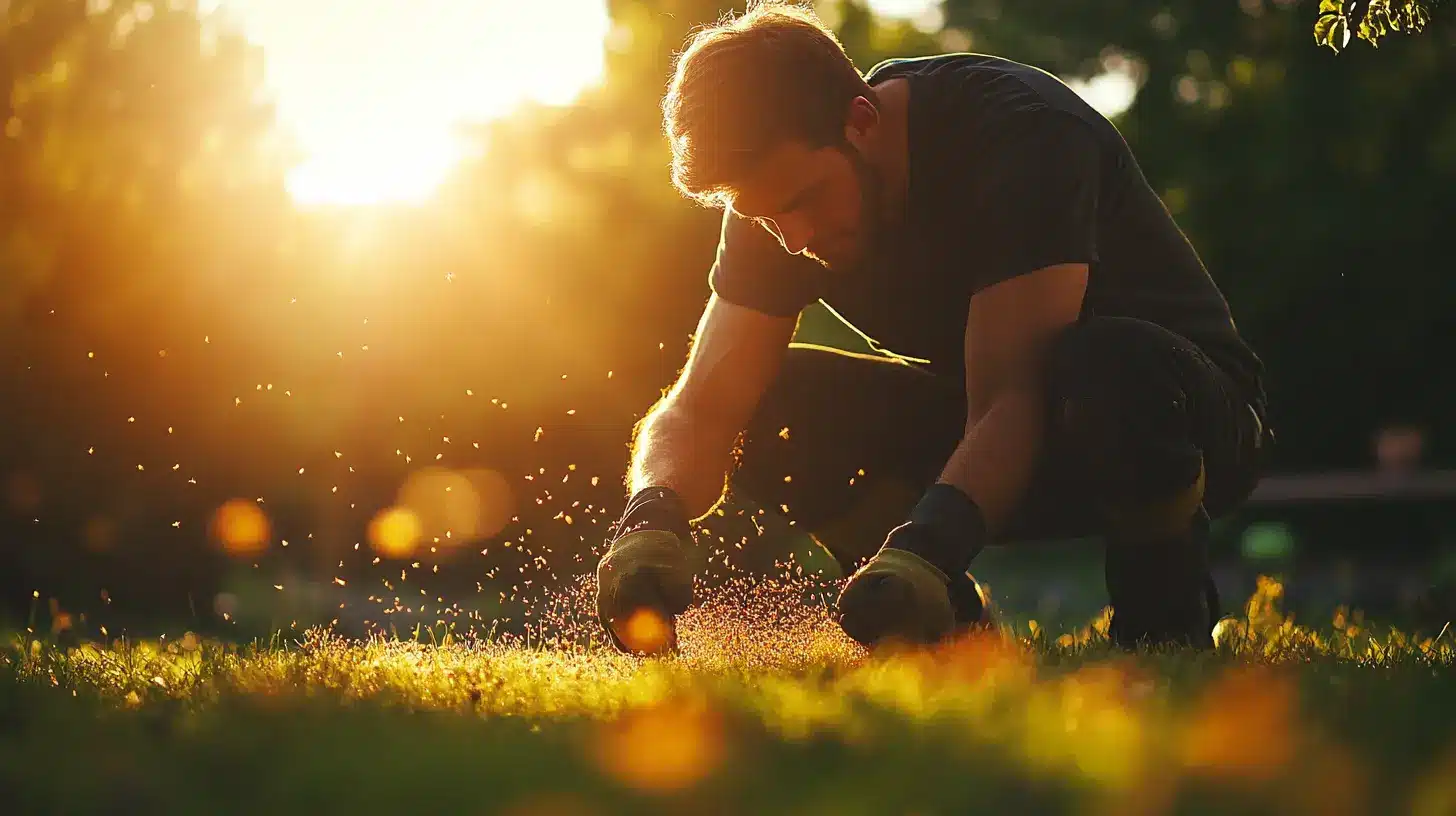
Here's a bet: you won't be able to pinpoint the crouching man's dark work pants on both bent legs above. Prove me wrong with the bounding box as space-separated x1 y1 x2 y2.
731 318 1265 570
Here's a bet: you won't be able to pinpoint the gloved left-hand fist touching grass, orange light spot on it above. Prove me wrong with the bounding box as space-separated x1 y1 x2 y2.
597 529 693 654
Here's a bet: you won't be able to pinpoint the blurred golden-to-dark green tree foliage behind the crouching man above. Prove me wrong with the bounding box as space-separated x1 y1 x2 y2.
0 0 1456 635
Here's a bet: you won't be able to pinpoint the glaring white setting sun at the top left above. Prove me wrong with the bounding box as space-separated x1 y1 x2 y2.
226 0 610 204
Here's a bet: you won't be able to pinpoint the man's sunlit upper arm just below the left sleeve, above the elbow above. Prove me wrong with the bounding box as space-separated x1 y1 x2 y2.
668 294 798 433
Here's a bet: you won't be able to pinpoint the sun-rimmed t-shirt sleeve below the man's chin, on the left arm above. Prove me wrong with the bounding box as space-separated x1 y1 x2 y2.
708 208 823 318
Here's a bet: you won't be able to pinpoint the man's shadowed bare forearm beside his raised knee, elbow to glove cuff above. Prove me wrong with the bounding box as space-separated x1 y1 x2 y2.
941 388 1045 535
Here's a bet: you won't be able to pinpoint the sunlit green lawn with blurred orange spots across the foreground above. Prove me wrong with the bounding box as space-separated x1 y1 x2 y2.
0 581 1456 816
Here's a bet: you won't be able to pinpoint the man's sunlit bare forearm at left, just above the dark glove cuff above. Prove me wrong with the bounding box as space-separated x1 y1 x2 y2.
628 399 738 519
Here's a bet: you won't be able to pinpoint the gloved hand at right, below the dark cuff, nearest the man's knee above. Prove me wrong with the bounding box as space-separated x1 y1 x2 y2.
839 535 957 647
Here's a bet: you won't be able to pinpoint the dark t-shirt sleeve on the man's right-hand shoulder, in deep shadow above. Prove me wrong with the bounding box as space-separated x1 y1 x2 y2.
965 111 1102 291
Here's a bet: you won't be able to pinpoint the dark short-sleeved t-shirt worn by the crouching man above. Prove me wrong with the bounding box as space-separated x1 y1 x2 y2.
709 54 1264 412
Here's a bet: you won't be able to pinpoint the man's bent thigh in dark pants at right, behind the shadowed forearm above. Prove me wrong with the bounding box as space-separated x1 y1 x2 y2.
999 318 1264 542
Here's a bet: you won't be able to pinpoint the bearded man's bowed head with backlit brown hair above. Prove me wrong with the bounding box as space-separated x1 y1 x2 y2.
662 1 884 268
